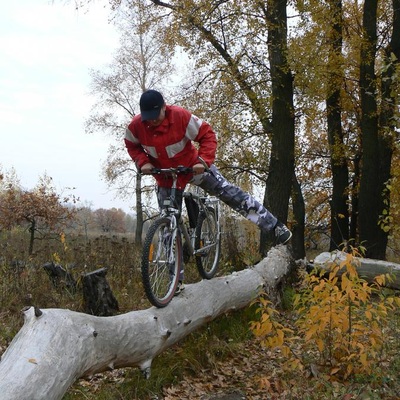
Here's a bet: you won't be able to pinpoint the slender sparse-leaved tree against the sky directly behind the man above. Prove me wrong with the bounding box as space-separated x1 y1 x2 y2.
86 1 174 243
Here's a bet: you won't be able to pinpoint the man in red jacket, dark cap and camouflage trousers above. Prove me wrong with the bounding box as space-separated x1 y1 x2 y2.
125 90 292 290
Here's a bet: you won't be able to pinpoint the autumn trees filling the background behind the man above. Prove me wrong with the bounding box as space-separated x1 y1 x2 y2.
0 1 400 259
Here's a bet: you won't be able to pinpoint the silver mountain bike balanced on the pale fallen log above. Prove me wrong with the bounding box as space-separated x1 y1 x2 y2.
141 167 221 308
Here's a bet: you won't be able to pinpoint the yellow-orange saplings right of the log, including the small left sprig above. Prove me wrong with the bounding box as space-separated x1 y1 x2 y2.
251 247 400 380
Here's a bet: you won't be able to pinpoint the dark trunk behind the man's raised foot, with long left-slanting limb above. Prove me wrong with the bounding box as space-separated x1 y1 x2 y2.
151 0 295 254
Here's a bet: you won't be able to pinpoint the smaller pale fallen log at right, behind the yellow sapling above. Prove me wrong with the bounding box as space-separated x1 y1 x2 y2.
313 251 400 290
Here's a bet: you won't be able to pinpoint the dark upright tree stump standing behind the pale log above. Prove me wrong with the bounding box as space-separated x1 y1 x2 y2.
82 268 119 317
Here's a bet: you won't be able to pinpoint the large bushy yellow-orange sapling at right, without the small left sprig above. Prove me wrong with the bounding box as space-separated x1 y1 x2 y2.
294 250 400 377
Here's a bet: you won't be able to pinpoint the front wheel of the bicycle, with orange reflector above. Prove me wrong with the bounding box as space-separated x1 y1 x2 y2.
142 217 182 308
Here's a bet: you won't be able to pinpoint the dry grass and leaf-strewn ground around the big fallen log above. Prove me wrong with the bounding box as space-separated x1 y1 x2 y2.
0 233 400 400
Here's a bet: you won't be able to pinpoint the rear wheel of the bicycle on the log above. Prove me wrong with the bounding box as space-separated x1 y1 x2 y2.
194 207 221 279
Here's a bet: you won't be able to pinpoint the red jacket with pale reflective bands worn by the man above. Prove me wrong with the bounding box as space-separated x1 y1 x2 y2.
125 106 217 189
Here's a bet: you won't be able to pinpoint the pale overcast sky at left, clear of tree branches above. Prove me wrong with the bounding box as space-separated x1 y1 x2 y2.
0 0 133 211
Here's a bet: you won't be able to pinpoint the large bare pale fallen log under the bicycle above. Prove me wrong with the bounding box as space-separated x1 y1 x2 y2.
0 246 292 400
